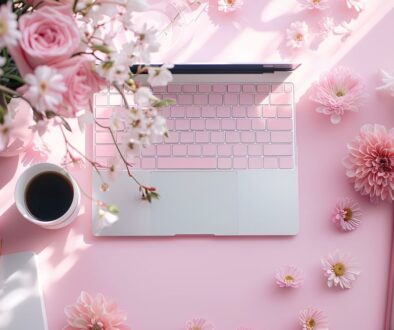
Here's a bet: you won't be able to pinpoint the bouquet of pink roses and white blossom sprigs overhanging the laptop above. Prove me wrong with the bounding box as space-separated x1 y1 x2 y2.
0 0 173 218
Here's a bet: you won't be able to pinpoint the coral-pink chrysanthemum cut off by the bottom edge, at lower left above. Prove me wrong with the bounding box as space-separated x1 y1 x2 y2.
64 291 129 330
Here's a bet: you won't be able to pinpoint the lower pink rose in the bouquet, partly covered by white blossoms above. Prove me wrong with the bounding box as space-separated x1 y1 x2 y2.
53 56 106 117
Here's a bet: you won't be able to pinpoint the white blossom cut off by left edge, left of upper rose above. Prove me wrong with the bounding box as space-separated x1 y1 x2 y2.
0 2 21 48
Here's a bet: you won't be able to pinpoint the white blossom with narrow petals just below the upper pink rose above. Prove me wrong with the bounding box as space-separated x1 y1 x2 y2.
24 65 67 112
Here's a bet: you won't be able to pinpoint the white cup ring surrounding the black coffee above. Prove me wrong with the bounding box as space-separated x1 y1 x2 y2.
14 163 81 228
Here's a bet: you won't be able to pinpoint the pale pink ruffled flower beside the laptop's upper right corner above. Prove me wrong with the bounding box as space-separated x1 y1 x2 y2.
310 67 364 124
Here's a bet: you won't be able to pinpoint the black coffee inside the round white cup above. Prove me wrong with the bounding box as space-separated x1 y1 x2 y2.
25 172 74 221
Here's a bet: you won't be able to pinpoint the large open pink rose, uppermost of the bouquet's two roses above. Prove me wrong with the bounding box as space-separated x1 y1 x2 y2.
10 6 80 76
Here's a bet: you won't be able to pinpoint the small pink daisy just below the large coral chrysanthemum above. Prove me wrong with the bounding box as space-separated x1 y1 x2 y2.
332 198 361 231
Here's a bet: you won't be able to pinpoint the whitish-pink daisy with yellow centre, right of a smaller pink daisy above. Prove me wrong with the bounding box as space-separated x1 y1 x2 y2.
321 250 360 289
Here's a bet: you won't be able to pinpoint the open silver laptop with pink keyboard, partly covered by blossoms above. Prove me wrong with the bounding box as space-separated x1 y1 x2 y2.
92 64 299 236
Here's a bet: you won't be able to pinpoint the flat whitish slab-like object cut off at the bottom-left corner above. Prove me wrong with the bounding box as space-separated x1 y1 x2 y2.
0 252 48 330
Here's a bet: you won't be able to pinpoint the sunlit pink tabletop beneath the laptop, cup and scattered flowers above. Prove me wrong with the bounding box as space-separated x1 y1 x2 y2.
0 0 394 330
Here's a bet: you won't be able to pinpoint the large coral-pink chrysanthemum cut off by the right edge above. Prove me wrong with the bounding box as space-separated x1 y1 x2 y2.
344 124 394 202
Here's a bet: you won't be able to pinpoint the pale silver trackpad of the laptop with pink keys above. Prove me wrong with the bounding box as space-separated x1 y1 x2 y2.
150 171 238 235
